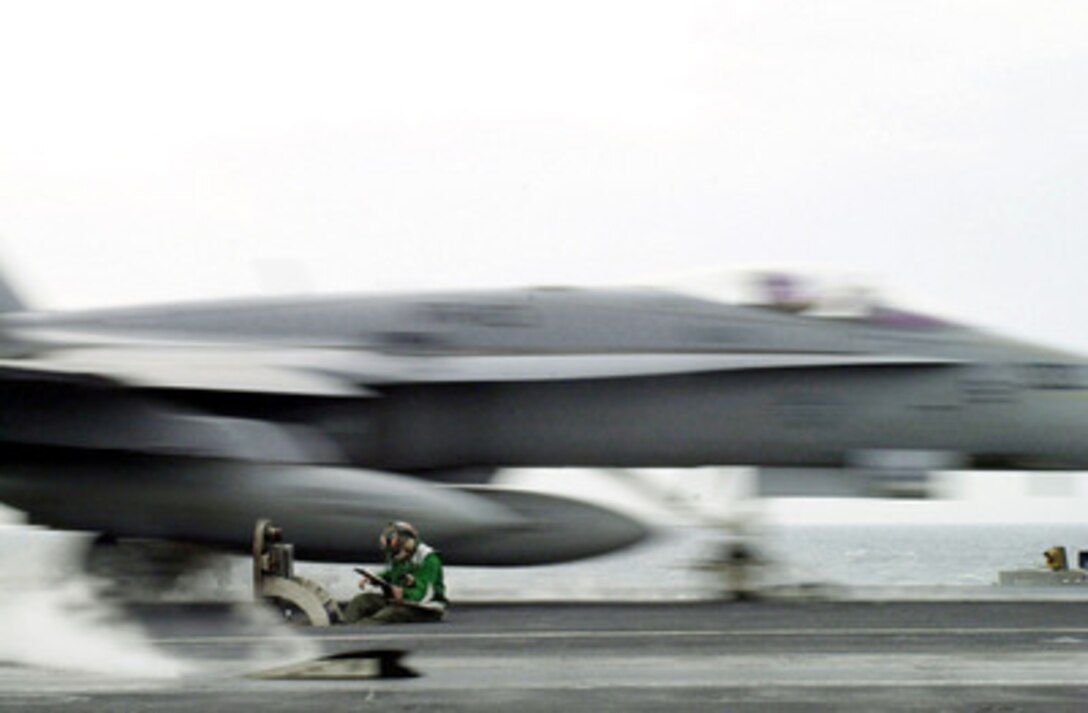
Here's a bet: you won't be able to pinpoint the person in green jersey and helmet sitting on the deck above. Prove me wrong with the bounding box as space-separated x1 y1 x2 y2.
344 520 448 624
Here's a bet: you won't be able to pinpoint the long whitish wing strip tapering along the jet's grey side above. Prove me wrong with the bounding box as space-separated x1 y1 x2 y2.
0 343 959 397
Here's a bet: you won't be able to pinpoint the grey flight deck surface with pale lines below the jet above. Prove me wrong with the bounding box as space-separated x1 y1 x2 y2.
0 601 1088 713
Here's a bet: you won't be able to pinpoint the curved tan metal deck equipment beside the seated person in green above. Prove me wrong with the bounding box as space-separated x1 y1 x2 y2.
254 519 344 627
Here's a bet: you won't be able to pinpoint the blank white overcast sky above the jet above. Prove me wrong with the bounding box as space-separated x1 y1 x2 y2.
0 0 1088 352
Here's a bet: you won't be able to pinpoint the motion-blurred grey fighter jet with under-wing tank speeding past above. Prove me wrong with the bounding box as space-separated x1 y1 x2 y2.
0 275 1088 564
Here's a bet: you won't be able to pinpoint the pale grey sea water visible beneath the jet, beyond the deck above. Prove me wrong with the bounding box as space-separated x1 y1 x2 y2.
301 523 1088 601
